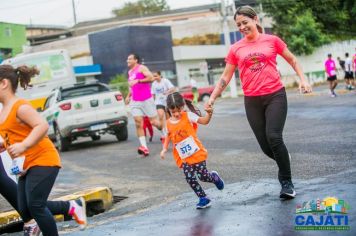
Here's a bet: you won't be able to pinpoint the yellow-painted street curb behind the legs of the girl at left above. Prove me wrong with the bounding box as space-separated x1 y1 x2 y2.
0 187 113 230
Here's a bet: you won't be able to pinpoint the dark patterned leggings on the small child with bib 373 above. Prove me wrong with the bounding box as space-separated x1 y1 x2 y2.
183 161 214 197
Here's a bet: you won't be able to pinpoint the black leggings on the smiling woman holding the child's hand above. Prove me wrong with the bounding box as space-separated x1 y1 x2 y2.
245 88 292 181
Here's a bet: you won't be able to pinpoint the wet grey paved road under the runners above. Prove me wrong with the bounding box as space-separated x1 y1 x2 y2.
3 86 356 235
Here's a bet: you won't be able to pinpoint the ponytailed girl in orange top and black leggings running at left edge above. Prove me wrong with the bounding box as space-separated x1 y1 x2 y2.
0 65 86 236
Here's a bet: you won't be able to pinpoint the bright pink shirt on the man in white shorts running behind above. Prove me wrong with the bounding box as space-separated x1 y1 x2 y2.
128 65 152 102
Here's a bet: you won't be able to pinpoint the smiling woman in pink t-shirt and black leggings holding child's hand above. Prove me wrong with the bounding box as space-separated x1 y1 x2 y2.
208 6 311 199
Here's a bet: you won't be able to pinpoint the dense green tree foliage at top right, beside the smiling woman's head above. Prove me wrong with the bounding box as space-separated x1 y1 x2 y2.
259 0 356 55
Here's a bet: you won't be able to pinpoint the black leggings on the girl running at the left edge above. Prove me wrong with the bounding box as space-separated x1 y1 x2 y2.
17 166 69 236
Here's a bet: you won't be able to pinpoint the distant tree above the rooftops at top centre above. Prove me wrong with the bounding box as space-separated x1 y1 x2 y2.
112 0 169 16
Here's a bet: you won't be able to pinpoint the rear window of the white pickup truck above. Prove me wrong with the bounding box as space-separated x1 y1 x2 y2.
61 84 110 100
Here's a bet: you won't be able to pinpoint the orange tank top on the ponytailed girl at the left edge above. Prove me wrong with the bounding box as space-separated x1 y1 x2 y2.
0 99 61 169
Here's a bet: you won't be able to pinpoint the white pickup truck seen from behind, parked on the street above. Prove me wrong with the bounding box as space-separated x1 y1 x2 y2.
41 82 128 151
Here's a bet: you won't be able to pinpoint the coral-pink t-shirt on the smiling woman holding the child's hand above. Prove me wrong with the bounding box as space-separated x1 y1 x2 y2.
225 34 287 96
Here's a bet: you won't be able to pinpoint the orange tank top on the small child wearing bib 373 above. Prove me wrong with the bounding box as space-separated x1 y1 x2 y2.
167 112 208 168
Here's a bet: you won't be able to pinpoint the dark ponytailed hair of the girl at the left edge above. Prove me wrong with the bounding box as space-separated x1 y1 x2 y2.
0 65 39 93
